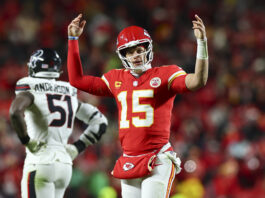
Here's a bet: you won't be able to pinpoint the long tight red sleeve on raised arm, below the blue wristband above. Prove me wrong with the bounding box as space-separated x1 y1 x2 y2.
67 40 112 96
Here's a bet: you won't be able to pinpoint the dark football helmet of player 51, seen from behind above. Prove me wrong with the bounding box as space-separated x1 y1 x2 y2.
28 48 62 78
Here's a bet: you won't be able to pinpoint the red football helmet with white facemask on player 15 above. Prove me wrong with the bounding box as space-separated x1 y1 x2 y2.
116 26 153 71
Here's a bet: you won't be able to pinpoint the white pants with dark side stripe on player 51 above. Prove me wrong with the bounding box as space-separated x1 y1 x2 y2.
21 162 72 198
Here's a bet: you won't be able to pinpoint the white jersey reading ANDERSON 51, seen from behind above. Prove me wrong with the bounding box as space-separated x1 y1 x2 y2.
16 77 78 164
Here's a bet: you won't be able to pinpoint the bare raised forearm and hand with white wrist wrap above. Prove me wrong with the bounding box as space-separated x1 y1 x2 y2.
185 15 209 91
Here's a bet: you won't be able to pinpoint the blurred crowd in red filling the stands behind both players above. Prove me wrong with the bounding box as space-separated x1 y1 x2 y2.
0 0 265 198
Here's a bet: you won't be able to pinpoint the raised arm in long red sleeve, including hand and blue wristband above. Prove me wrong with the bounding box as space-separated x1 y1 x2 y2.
67 14 112 96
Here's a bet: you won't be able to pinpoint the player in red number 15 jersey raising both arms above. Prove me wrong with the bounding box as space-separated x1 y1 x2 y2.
67 14 208 198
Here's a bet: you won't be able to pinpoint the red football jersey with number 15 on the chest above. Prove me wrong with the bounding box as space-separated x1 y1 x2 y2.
102 65 187 155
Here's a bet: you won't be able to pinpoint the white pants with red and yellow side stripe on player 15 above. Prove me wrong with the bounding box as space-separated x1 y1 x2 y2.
121 153 176 198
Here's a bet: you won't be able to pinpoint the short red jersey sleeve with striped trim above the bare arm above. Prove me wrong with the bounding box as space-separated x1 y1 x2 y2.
167 65 189 93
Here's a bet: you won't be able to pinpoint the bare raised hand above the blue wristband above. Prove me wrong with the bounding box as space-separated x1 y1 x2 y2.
68 14 86 37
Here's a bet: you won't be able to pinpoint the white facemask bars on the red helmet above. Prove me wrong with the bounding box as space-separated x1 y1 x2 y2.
116 39 153 72
